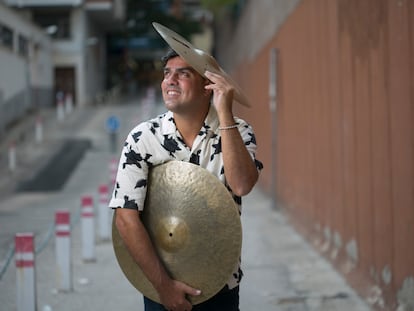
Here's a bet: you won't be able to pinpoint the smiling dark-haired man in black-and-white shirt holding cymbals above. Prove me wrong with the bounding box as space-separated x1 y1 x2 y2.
110 50 261 311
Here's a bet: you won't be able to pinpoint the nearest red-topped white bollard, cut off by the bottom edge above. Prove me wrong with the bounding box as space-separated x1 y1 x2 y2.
15 233 36 311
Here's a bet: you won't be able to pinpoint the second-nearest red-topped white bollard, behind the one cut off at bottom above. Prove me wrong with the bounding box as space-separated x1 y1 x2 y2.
55 210 72 292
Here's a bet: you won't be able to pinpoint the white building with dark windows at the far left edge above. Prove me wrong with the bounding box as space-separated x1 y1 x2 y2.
0 2 53 133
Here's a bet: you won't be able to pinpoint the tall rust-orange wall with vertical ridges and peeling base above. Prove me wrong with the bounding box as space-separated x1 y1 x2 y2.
235 0 414 310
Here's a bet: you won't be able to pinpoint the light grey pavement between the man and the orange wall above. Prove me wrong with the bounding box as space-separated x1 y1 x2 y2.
241 188 370 311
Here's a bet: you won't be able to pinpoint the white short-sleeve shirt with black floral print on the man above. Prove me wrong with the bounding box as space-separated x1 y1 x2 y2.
109 106 262 289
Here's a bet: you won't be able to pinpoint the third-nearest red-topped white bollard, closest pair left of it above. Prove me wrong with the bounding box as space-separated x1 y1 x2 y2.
81 195 95 262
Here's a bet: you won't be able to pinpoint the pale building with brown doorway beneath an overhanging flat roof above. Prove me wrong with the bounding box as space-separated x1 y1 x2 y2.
4 0 125 106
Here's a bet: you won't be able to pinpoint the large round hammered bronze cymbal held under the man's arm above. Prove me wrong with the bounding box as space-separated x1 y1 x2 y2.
112 161 242 304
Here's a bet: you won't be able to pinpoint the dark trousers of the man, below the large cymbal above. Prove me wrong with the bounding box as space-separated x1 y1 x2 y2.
144 287 240 311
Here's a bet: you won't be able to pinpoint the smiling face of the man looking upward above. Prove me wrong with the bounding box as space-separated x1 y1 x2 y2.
161 57 209 112
